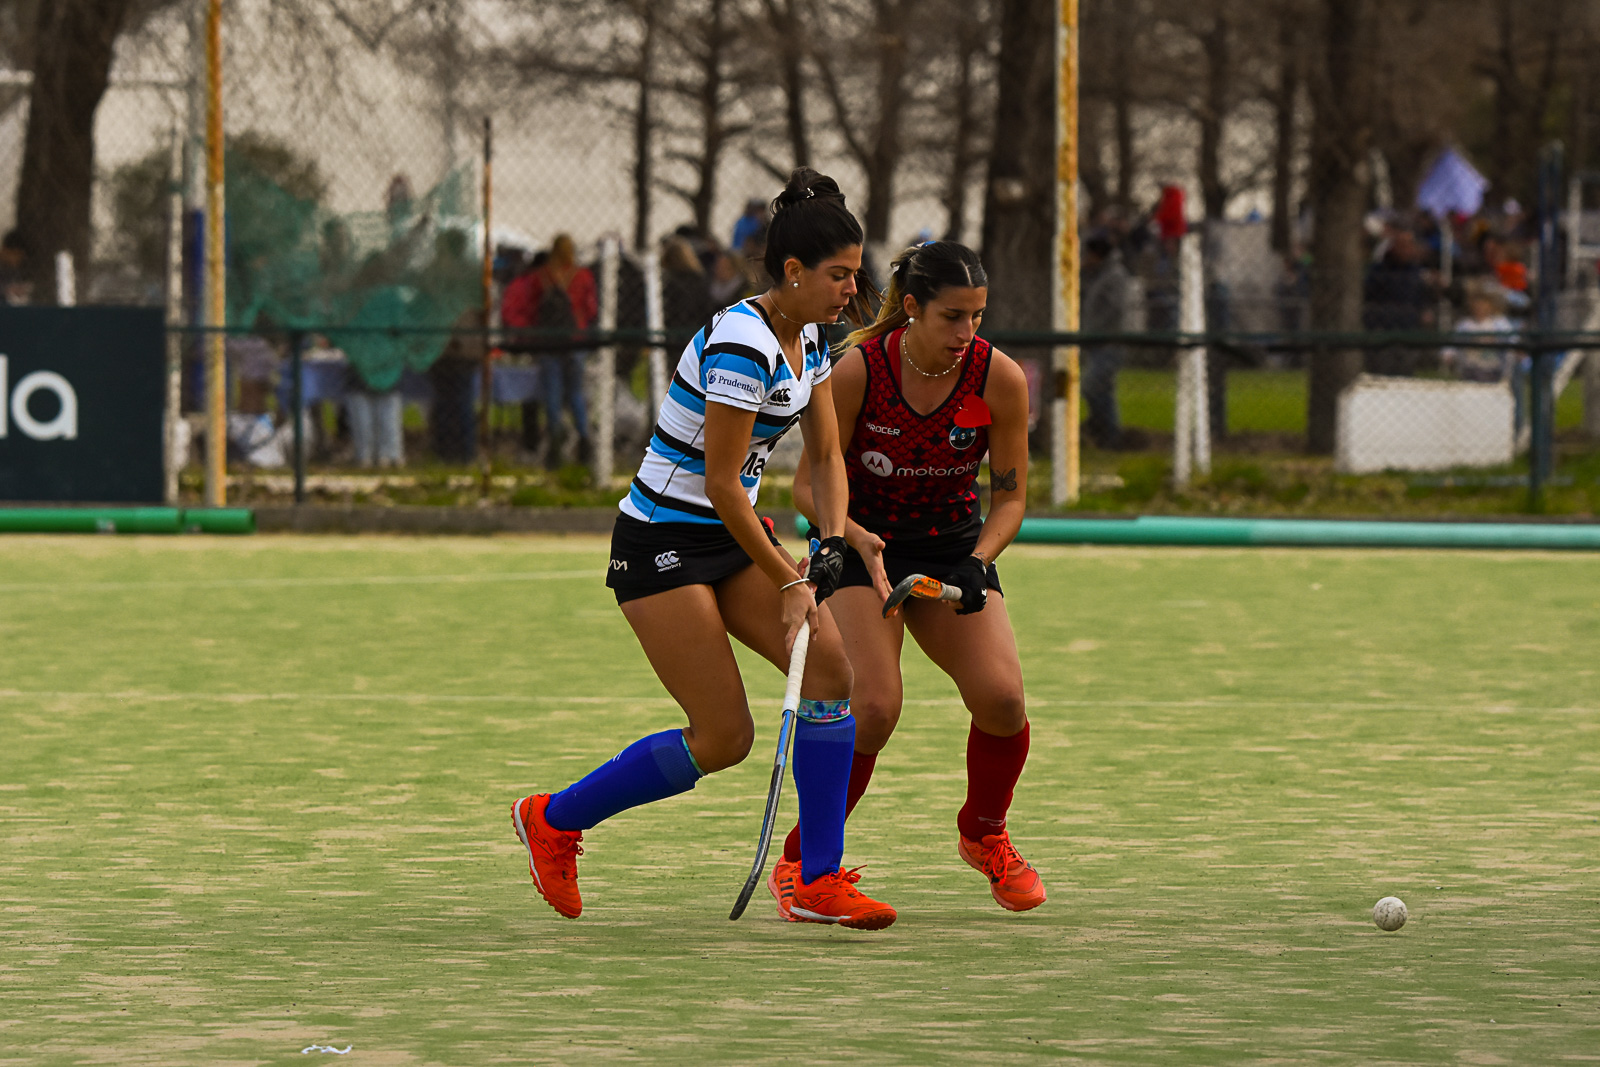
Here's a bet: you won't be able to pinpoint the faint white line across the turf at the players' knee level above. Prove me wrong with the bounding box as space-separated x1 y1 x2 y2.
0 689 1600 715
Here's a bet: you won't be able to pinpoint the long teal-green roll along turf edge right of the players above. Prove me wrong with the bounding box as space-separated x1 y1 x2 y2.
1016 515 1600 550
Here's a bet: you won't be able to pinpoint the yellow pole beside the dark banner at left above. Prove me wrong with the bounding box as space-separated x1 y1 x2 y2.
205 0 227 507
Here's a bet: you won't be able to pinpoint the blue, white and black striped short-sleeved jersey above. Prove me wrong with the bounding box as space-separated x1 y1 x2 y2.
622 301 834 523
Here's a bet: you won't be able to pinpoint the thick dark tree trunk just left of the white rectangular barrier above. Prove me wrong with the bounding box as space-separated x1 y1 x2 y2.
1306 0 1378 454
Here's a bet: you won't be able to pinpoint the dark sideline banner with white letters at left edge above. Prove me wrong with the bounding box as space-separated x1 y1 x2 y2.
0 307 166 504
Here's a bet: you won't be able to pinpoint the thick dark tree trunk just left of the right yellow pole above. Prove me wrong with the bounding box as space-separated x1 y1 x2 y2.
984 0 1056 438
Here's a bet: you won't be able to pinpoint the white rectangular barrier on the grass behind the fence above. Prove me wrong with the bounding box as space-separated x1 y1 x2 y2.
1334 374 1515 474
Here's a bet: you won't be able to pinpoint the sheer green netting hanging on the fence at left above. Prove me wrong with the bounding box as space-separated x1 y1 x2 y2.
227 152 482 390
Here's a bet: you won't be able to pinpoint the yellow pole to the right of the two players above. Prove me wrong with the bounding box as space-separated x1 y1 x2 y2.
1050 0 1082 507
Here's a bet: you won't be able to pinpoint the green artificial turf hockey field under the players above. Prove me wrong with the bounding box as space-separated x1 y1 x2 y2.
0 536 1600 1067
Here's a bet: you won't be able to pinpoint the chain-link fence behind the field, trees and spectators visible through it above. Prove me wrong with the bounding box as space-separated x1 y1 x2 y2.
9 0 1600 512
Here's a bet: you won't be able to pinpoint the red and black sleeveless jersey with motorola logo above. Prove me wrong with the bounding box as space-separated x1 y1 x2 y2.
845 330 990 547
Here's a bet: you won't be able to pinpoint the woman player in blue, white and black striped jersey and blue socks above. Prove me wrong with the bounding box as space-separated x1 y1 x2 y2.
512 168 894 929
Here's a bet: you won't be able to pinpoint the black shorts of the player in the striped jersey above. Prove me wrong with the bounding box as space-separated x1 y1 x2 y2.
605 515 782 603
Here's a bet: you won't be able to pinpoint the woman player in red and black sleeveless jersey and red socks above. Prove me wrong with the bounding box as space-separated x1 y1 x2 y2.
768 242 1045 918
